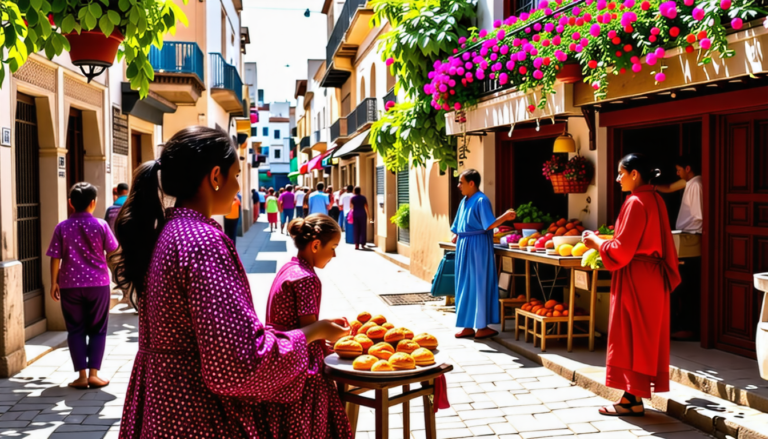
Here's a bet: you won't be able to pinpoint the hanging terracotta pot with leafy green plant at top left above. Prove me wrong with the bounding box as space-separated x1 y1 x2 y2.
0 0 188 98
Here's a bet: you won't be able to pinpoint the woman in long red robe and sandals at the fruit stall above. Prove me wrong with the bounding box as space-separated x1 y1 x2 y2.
584 154 680 416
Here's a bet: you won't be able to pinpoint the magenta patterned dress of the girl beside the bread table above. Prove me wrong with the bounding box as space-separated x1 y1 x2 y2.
260 258 352 439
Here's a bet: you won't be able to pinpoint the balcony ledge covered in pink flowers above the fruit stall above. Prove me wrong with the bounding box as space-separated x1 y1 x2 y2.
423 0 768 134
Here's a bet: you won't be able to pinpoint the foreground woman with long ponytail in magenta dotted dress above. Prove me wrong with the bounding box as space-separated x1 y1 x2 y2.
113 127 349 438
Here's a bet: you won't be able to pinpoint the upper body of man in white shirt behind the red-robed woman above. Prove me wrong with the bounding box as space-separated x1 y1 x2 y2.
656 157 704 234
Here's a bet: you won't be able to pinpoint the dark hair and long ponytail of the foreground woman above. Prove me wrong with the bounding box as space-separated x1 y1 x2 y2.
111 126 237 296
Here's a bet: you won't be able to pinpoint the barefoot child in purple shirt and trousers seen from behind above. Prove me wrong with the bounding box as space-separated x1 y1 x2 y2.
46 183 118 389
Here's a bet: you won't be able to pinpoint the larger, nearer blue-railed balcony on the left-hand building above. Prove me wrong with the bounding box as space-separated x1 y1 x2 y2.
149 41 205 105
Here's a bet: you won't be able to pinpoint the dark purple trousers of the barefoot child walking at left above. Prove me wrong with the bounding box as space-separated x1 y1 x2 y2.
61 285 110 371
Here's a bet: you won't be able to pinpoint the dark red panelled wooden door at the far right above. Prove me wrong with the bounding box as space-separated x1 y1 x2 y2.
714 110 768 358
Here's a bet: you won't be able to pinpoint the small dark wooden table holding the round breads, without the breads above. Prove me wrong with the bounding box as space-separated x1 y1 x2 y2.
325 363 453 439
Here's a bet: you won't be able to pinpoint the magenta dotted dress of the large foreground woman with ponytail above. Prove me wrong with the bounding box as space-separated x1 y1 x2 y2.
120 208 308 438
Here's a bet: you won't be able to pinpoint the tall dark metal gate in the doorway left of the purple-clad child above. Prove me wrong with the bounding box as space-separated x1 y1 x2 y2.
15 94 45 334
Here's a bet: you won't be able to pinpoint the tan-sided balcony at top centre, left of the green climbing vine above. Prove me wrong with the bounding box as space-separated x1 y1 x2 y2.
320 0 373 87
